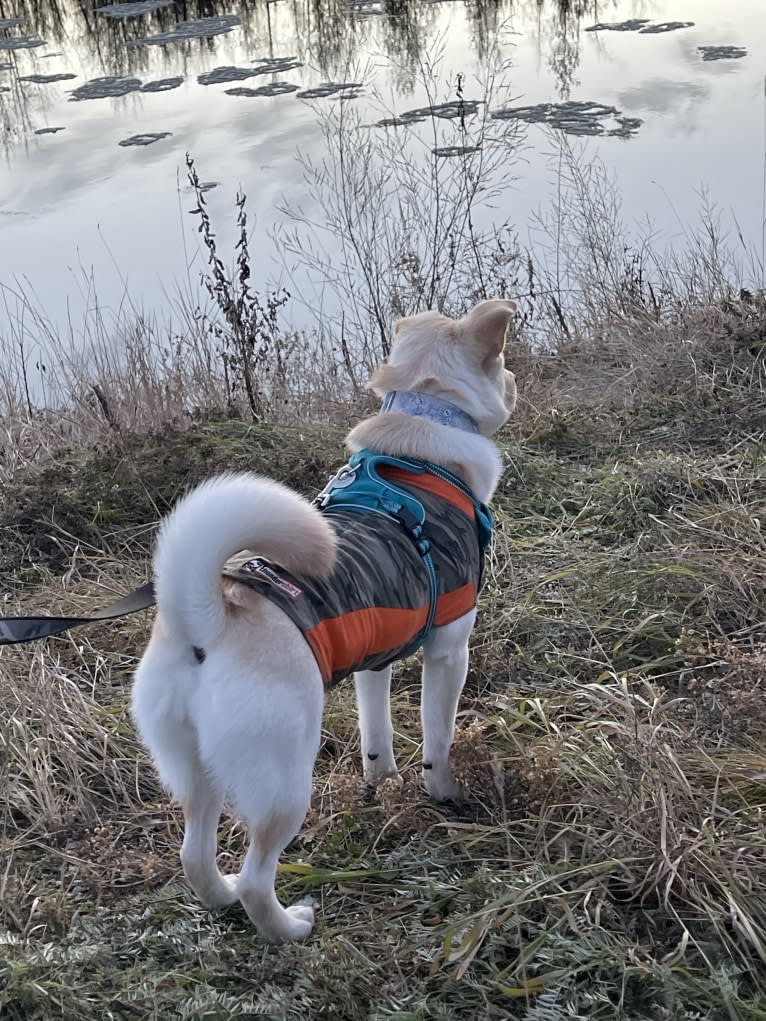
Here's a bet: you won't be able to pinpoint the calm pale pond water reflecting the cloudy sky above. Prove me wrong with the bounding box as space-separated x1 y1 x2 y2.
0 0 766 347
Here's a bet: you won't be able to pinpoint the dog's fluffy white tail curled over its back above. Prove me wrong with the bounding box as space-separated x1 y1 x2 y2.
154 474 336 648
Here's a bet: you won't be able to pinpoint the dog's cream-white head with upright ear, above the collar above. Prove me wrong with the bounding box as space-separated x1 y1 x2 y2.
369 298 516 436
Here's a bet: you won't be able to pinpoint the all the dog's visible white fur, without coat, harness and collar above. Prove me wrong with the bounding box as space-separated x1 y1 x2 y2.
133 301 516 942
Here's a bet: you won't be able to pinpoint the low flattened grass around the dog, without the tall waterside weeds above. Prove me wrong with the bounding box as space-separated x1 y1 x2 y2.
0 304 766 1021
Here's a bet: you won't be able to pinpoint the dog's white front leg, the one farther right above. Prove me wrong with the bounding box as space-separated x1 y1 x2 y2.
421 610 476 801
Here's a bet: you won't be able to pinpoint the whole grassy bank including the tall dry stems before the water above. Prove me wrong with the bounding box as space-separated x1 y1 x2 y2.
0 51 766 1021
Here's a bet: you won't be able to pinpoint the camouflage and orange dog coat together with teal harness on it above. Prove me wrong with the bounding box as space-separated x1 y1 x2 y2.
224 450 492 687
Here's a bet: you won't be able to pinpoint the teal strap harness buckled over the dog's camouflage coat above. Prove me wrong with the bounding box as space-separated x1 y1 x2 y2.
314 449 494 643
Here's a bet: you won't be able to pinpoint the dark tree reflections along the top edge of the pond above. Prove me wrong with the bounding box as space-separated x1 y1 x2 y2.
0 0 617 137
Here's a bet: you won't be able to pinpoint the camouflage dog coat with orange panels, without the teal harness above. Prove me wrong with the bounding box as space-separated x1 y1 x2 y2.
224 475 483 686
